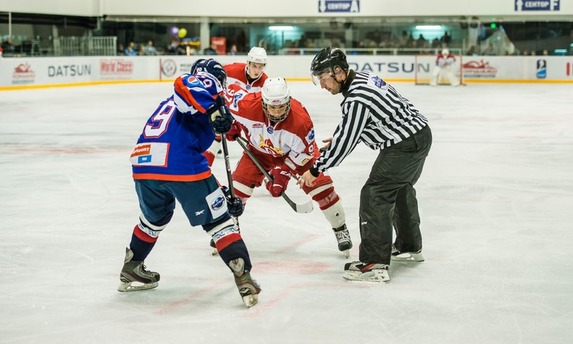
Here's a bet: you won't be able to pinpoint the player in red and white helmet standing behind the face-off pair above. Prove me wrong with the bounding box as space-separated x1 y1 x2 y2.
204 47 268 166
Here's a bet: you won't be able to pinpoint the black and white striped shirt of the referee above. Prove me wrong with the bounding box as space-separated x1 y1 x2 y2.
313 71 428 172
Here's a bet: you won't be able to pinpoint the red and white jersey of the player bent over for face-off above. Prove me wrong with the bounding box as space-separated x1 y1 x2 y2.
225 85 320 174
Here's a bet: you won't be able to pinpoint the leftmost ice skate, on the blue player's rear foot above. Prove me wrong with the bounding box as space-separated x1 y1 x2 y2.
117 248 159 292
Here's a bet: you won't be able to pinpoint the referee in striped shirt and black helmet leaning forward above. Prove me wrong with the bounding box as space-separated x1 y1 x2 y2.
300 47 432 282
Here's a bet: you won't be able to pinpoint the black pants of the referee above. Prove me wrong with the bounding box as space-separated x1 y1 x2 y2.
359 126 432 264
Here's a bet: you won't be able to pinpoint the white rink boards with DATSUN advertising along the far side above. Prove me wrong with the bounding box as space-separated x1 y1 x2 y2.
0 55 573 90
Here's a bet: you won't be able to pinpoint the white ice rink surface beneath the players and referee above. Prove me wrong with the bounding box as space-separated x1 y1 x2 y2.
0 82 573 344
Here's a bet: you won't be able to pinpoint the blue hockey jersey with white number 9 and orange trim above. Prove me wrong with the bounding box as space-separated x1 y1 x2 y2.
130 72 223 181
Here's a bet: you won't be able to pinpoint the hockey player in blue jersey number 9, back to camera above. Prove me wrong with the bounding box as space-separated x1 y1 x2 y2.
118 59 261 307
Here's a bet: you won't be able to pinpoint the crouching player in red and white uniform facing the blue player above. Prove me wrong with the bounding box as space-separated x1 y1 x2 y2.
226 78 352 257
